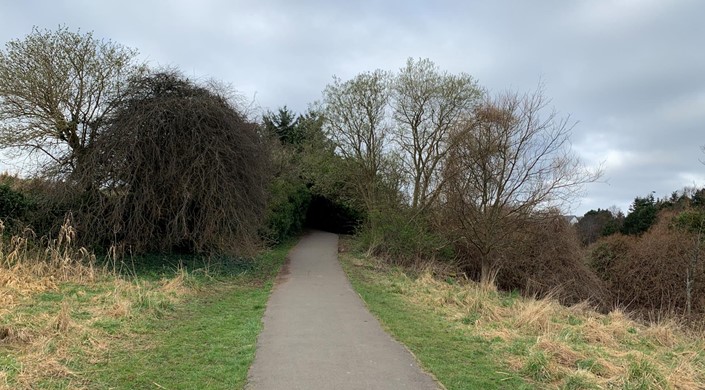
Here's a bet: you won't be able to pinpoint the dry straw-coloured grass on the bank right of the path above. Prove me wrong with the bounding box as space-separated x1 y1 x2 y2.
376 260 705 389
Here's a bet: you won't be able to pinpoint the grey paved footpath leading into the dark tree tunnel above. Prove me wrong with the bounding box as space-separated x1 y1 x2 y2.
246 232 439 390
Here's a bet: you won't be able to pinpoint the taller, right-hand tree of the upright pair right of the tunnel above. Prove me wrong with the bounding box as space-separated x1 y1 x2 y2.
393 58 482 210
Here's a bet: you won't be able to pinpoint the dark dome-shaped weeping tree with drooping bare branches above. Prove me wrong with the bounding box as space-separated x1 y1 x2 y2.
86 72 269 253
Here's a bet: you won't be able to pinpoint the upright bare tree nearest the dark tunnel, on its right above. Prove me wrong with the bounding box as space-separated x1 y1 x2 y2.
323 70 390 215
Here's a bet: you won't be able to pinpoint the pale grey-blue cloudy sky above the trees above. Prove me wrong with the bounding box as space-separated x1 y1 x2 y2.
0 0 705 215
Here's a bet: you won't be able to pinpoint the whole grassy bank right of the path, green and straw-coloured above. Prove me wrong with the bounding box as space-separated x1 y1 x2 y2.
341 239 705 389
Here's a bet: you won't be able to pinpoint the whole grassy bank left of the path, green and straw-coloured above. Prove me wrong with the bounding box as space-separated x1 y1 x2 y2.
0 233 291 389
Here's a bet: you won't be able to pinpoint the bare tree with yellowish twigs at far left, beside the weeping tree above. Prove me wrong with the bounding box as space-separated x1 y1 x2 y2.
0 27 145 173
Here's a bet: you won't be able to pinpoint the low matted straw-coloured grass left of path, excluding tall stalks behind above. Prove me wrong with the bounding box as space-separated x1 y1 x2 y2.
0 277 188 389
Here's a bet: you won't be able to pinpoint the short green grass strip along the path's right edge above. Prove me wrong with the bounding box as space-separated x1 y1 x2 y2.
341 251 532 390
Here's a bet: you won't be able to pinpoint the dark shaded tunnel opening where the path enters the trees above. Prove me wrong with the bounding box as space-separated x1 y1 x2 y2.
305 195 361 234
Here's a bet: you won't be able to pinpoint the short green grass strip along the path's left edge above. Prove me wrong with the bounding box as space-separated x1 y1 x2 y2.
87 245 291 389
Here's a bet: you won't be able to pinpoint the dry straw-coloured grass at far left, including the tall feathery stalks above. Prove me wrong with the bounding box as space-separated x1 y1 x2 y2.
0 221 191 389
